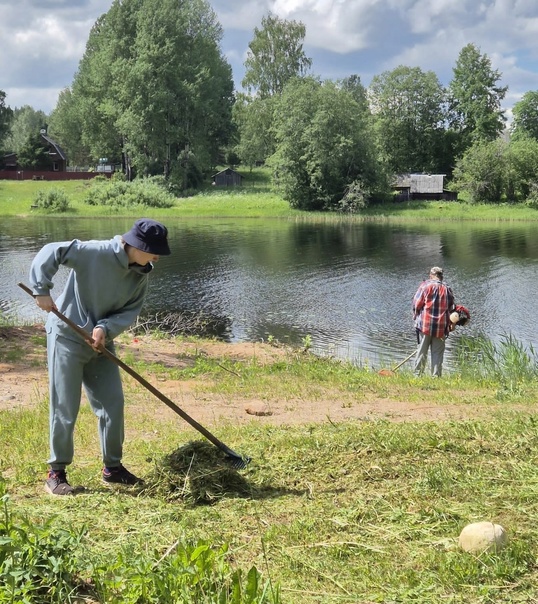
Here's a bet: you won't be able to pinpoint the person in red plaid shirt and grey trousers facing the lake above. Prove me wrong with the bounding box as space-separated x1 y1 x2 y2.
413 266 455 377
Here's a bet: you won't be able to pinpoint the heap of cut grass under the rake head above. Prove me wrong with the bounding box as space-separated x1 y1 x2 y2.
142 440 251 505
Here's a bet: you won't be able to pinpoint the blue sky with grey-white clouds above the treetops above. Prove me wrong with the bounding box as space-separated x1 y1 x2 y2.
0 0 538 120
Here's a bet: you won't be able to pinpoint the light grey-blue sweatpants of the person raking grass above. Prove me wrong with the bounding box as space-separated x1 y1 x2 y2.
47 331 124 470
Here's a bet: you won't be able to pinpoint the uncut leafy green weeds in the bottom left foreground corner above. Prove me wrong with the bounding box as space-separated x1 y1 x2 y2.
0 490 280 604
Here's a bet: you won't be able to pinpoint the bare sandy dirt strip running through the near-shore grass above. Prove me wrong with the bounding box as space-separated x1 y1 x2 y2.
0 325 494 426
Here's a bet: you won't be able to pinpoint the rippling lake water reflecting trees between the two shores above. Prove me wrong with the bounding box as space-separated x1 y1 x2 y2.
0 216 538 369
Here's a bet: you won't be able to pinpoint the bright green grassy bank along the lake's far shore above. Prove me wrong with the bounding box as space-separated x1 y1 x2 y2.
0 177 538 222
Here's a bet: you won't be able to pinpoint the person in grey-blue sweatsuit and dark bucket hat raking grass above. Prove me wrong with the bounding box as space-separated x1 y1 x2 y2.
29 219 170 495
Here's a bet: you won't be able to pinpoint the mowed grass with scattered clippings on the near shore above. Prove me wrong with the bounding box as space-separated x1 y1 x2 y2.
0 332 538 604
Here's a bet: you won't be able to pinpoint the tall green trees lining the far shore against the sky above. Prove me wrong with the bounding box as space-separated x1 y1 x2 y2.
0 0 538 211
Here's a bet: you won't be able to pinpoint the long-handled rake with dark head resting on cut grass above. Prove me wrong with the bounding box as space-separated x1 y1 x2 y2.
17 283 251 470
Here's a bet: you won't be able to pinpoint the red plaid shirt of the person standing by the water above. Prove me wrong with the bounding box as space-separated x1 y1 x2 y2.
413 279 454 338
